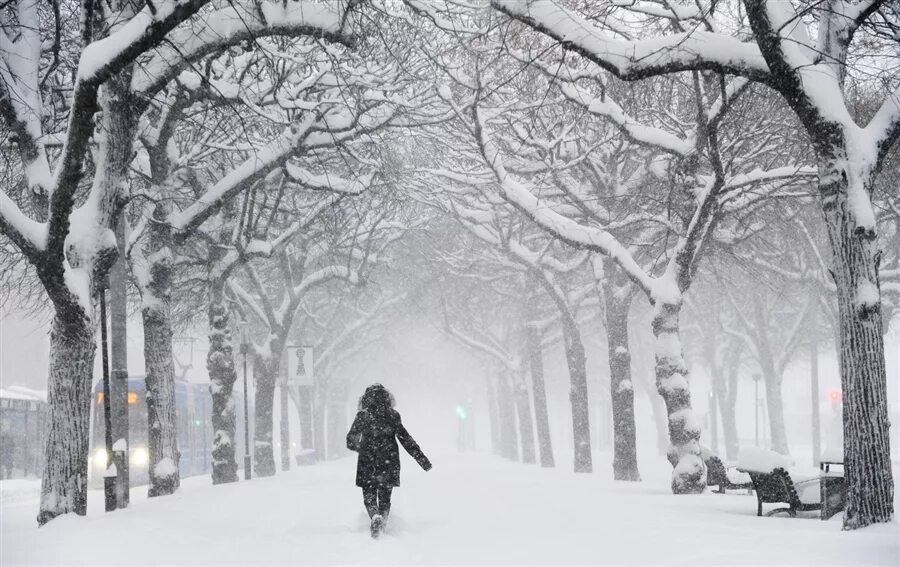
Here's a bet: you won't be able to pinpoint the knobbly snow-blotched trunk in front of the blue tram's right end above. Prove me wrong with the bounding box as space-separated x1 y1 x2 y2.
206 278 238 484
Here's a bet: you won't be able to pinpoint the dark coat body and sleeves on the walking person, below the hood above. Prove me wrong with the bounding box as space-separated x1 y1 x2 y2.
347 408 431 488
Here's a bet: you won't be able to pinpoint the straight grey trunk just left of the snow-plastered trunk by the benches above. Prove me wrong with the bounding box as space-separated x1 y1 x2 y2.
604 286 641 481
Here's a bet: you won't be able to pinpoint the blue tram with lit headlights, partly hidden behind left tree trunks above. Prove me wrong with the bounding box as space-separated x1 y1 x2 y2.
88 376 253 487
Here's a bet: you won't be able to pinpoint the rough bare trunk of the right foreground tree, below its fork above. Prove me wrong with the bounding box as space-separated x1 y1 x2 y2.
819 166 894 529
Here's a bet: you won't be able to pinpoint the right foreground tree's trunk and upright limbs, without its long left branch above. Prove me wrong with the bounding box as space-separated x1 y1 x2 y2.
745 1 900 530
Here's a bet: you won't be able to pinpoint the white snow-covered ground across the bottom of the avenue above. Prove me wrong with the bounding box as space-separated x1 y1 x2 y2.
0 455 900 566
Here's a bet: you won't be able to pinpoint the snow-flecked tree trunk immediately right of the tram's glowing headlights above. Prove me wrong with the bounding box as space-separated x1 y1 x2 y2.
141 210 180 496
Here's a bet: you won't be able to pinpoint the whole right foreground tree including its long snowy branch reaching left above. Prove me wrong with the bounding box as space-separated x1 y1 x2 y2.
491 0 900 529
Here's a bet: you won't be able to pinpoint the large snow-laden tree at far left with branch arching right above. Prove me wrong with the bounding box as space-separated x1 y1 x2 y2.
0 0 352 524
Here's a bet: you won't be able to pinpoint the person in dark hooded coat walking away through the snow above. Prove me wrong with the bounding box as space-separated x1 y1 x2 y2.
347 384 431 538
